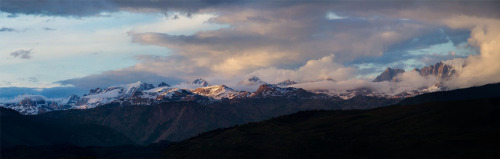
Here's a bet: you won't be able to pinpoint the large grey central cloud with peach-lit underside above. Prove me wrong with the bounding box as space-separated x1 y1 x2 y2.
129 5 429 80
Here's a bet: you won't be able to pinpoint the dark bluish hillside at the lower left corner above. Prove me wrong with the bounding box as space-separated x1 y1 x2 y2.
0 108 135 148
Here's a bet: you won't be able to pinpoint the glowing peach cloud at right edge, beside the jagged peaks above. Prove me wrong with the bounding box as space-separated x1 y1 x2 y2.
444 16 500 88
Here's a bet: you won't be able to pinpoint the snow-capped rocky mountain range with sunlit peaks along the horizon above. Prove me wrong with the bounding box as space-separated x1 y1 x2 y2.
0 60 464 115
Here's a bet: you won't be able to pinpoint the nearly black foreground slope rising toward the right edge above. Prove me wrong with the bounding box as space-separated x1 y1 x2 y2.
164 98 500 158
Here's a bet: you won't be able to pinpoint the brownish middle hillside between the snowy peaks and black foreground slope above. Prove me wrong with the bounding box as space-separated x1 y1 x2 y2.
36 97 399 145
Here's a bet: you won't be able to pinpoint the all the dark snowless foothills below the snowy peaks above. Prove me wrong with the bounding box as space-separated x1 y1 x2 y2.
0 83 500 158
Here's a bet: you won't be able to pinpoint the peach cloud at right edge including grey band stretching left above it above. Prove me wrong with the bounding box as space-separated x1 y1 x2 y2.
372 1 500 89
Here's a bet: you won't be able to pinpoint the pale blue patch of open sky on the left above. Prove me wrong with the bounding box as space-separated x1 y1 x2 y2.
0 12 224 88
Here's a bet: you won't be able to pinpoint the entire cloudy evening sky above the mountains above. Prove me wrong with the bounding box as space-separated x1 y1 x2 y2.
0 0 500 98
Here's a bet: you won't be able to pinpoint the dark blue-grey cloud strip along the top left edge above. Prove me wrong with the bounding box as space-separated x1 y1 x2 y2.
0 0 246 17
